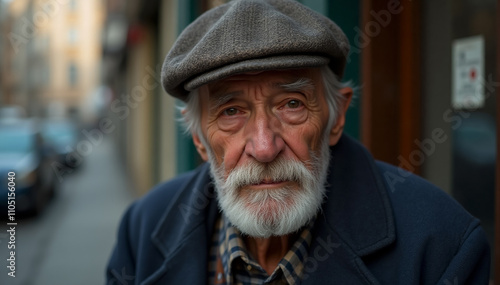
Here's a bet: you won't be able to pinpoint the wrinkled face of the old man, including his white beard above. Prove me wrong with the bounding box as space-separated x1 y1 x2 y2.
195 69 336 237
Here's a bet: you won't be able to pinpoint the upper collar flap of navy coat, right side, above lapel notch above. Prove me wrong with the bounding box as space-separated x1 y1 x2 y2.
323 135 396 256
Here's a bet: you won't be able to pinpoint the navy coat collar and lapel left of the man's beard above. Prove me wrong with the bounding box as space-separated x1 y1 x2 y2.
141 164 218 285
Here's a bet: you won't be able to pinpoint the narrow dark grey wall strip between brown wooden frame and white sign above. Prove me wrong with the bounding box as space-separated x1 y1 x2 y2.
422 0 453 193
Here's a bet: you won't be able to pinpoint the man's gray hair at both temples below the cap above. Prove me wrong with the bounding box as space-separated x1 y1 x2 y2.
179 66 351 144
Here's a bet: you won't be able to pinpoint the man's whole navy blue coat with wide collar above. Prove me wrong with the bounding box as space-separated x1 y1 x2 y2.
107 136 490 285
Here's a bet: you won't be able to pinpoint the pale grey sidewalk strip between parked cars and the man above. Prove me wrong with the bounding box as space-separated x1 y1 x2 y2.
33 136 137 285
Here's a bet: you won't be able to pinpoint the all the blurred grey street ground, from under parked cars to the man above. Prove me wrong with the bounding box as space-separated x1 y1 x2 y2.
0 138 133 285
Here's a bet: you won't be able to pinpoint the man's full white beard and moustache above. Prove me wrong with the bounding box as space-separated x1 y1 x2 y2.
208 136 330 238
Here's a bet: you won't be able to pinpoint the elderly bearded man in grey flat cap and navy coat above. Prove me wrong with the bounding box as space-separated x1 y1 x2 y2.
107 0 490 285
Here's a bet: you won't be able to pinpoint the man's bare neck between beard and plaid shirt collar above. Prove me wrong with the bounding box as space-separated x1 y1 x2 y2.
244 234 297 275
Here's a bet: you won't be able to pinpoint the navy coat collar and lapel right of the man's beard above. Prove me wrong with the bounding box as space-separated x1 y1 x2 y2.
303 136 396 285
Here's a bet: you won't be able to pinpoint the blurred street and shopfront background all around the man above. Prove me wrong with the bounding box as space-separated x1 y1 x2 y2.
0 0 500 285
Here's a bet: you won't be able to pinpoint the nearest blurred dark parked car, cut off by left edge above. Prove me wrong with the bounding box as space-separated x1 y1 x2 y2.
0 120 58 215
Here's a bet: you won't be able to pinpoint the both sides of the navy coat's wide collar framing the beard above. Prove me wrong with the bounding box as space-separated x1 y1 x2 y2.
143 135 396 284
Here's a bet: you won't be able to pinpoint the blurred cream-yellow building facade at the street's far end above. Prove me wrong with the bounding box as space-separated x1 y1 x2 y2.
1 0 105 121
